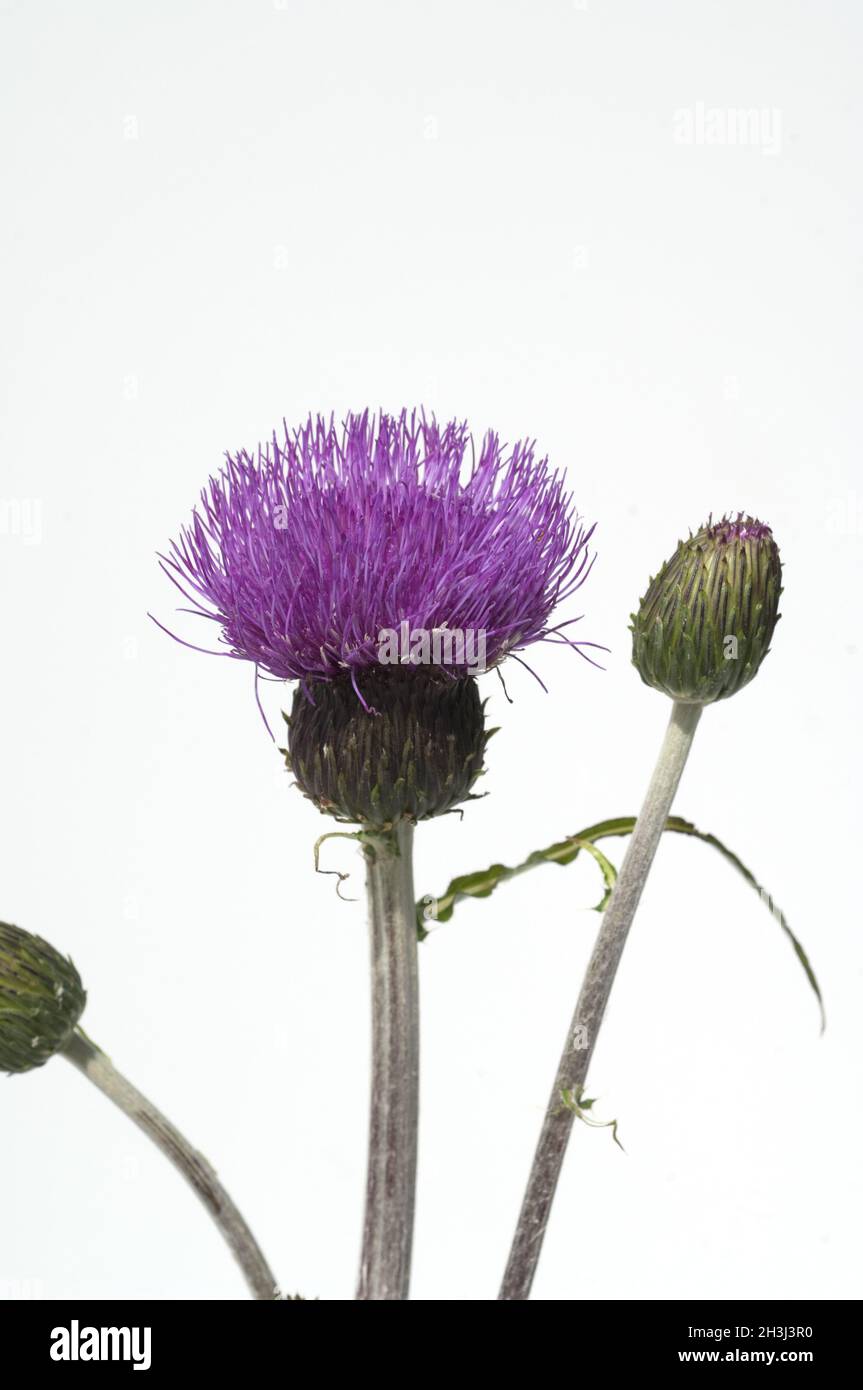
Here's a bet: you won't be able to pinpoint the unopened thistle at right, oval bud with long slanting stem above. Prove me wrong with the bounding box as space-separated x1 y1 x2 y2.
500 513 789 1301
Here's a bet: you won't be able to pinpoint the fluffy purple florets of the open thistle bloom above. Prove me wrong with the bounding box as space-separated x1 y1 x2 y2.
160 411 596 688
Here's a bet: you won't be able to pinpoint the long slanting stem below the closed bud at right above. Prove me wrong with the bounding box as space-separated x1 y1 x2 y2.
499 702 702 1300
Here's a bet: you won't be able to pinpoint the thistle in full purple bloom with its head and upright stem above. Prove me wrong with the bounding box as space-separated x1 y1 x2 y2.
163 411 593 1300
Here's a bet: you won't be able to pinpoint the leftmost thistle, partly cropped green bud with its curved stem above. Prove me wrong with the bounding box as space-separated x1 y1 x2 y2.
0 922 277 1300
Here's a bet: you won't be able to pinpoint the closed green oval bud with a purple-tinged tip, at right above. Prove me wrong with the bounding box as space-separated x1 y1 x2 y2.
631 513 782 705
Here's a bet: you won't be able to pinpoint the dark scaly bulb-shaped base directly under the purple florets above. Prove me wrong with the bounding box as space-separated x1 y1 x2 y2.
285 666 489 828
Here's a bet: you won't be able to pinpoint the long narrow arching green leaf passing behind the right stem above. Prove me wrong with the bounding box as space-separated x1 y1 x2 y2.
417 816 825 1031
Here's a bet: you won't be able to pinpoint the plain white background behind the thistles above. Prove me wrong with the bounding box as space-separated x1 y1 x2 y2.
0 0 863 1300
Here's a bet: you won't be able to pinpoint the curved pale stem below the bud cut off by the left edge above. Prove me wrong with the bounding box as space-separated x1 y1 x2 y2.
61 1031 278 1300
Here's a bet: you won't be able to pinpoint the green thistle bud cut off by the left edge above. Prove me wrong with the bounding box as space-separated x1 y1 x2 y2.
0 922 86 1072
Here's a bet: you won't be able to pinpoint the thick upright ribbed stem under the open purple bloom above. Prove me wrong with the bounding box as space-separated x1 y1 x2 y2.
357 821 420 1300
